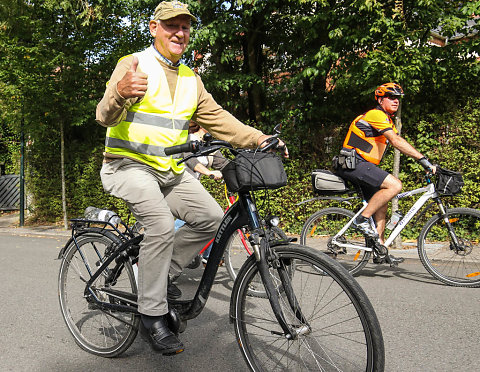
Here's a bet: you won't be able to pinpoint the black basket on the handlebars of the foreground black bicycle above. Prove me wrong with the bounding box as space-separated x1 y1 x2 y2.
222 150 287 192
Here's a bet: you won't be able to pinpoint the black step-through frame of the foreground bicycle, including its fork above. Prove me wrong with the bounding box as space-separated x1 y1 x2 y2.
68 192 296 339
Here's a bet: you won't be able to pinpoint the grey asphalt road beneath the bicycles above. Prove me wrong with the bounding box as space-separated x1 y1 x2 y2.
0 229 480 372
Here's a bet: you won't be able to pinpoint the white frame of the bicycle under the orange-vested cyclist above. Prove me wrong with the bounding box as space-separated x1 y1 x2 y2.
332 183 445 252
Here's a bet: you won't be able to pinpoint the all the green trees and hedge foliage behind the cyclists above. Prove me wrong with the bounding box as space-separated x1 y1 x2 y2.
0 0 480 232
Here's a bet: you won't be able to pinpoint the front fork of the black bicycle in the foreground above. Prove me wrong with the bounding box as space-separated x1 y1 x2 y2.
252 234 311 340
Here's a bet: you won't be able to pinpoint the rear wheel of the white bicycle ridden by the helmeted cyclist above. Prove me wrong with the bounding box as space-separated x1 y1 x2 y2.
300 207 371 275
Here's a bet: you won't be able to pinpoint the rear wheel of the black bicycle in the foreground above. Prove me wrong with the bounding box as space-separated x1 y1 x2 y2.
58 228 140 358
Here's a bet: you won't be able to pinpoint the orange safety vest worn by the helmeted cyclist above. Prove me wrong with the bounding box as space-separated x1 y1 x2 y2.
343 109 397 165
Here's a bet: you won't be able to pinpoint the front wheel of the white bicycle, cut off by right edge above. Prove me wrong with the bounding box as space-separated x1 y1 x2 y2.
417 208 480 287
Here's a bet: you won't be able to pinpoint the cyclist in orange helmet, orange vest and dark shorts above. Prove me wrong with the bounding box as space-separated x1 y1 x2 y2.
336 83 436 264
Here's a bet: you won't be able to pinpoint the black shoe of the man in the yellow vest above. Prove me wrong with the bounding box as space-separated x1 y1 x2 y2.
140 316 184 355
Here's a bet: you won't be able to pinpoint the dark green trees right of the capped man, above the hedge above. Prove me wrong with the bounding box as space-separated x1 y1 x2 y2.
192 0 479 160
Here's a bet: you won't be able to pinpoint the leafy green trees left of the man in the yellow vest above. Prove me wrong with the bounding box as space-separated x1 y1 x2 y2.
0 0 156 224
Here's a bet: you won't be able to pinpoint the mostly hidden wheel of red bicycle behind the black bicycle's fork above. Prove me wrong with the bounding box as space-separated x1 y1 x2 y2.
224 226 288 297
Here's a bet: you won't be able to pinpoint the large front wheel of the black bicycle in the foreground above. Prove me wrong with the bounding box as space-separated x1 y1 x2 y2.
231 244 385 372
